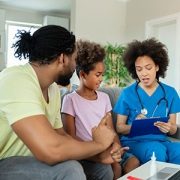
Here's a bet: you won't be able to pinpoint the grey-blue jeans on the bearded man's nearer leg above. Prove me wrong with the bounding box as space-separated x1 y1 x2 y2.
0 156 86 180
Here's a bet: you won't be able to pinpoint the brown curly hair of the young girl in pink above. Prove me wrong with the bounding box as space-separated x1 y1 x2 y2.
76 40 105 77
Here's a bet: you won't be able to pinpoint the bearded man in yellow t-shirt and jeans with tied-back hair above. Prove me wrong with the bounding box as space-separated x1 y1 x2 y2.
0 25 115 180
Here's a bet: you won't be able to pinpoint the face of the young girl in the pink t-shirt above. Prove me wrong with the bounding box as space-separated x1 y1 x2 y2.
82 62 105 90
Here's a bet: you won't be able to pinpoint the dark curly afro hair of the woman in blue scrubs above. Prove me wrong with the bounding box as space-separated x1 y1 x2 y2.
123 38 169 80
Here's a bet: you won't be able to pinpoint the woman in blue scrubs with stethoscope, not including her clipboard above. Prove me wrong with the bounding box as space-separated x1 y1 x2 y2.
114 39 180 164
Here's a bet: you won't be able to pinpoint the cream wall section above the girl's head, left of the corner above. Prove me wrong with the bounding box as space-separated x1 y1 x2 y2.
71 0 126 44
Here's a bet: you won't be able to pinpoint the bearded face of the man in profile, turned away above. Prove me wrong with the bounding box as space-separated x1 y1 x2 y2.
56 53 76 86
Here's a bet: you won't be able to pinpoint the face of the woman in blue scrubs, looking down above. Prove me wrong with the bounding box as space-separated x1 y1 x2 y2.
135 56 159 87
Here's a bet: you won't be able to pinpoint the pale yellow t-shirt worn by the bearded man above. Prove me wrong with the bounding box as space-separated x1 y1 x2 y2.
0 64 62 159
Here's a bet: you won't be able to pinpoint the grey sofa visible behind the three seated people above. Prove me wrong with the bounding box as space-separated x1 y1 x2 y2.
61 86 180 141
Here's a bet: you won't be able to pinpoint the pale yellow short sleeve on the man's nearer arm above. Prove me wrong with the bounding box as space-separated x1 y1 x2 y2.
0 69 44 124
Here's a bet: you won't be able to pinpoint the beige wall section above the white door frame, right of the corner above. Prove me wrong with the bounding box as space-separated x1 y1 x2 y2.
125 0 180 42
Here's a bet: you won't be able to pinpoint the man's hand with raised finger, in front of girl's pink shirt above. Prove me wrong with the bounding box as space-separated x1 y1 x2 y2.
92 113 115 150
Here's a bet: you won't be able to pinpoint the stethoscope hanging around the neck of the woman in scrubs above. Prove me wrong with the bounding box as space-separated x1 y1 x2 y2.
135 81 168 117
